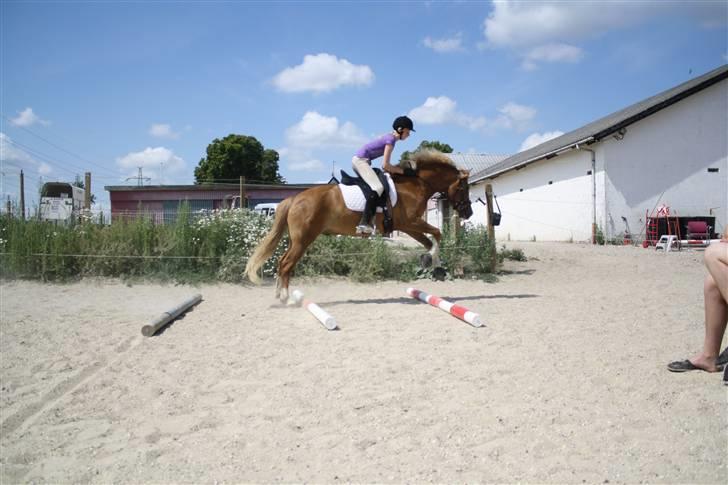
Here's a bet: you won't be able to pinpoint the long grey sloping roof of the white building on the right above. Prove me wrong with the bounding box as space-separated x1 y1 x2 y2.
470 65 728 183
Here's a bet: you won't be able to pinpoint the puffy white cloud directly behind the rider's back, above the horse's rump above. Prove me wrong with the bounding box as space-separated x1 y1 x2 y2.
278 111 366 170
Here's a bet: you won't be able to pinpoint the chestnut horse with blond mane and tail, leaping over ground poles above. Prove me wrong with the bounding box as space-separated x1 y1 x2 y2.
245 150 473 303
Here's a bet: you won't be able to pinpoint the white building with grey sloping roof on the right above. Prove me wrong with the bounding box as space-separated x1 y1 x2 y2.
470 65 728 241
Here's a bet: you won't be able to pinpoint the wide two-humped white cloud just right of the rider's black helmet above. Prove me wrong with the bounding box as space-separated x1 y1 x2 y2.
409 96 536 133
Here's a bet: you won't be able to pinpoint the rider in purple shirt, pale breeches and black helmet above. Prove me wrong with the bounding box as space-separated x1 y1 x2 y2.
351 116 415 234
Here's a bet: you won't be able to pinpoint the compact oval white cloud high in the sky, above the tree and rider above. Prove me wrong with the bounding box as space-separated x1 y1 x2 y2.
273 53 374 93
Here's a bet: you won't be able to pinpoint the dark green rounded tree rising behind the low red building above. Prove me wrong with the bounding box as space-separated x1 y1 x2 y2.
195 134 285 184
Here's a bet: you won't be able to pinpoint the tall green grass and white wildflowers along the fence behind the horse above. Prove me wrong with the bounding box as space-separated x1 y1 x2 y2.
0 209 524 283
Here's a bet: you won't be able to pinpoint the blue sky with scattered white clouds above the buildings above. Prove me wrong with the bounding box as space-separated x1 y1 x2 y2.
0 1 728 212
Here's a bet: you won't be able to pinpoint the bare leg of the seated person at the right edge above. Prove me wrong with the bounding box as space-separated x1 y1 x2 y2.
690 243 728 372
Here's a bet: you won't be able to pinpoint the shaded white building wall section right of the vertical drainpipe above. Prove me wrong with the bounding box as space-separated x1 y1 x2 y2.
602 81 728 237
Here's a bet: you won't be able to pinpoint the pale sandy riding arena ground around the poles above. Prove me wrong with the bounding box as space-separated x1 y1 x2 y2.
0 243 728 483
